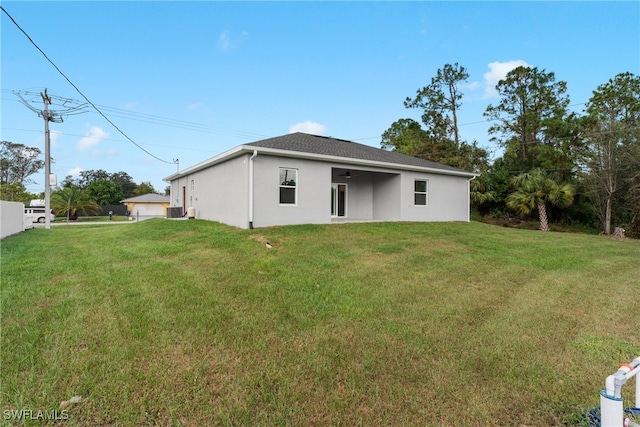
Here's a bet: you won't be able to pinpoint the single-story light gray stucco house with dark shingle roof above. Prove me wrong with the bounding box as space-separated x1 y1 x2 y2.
164 133 476 228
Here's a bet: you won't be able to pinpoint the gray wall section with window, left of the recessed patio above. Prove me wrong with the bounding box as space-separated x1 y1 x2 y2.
253 155 331 227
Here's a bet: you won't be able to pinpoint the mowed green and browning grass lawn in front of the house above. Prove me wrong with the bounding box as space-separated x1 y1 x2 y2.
1 219 640 426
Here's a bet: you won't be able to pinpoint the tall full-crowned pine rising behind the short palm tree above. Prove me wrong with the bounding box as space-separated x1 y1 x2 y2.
484 67 577 171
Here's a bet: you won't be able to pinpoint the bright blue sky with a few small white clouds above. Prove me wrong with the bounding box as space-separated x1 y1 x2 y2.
0 0 640 193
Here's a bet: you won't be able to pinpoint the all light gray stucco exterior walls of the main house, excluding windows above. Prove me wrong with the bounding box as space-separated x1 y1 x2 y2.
171 153 469 228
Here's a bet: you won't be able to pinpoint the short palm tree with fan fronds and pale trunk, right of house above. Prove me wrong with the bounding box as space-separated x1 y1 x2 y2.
506 169 575 231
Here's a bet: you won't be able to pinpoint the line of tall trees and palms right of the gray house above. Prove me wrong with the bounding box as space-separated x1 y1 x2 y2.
381 63 640 237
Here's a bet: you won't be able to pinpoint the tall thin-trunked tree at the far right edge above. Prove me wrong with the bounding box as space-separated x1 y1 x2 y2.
583 73 640 235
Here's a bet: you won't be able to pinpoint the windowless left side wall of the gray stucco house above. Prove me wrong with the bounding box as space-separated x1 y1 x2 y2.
171 155 250 228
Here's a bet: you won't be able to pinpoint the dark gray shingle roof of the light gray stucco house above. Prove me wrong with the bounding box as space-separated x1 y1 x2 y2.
244 132 471 173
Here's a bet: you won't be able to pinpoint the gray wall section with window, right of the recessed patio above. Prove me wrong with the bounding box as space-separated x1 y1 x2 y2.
401 172 469 221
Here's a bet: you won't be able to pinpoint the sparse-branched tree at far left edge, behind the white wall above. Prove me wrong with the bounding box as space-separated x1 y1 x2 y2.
0 141 44 184
